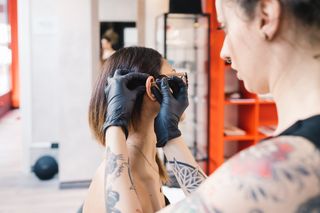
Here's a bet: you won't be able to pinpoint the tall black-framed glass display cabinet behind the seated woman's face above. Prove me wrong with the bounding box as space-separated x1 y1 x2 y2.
156 13 210 171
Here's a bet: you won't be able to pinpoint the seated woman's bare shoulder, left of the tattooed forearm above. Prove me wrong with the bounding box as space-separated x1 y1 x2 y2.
83 160 105 213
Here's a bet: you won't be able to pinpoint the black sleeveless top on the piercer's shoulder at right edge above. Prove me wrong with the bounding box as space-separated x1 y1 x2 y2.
279 115 320 150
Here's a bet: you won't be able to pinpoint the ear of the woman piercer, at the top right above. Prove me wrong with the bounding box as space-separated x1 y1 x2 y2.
257 0 281 41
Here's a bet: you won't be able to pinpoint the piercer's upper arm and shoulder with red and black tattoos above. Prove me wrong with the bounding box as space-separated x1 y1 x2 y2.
161 136 320 213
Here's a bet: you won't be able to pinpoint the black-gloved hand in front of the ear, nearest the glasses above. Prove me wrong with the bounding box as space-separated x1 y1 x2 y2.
154 77 189 147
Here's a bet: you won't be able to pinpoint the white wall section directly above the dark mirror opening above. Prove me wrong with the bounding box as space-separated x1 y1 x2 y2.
99 0 137 22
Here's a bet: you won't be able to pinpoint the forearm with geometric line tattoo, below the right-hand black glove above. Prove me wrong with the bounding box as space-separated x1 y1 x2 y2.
163 137 207 195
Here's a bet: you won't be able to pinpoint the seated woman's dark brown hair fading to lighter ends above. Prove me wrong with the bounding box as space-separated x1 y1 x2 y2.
89 47 167 181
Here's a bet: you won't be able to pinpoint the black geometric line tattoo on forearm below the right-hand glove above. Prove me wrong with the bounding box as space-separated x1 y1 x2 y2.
169 158 206 194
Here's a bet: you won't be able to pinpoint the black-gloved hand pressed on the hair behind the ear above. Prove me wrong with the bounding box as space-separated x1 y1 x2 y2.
103 70 148 138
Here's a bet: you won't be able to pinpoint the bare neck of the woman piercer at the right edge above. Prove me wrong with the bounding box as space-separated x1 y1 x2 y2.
270 45 320 134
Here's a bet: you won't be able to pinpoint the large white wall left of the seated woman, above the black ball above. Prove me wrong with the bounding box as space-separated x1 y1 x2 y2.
18 0 102 182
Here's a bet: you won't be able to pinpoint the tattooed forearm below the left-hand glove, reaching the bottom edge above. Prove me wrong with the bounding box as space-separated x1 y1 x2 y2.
105 126 142 213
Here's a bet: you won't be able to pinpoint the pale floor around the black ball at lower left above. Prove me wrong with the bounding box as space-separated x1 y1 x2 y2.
0 110 184 213
